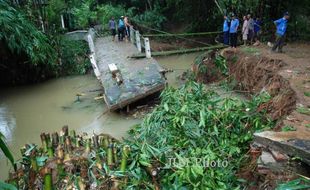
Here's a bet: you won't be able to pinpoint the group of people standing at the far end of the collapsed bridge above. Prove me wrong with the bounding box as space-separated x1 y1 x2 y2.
109 16 131 41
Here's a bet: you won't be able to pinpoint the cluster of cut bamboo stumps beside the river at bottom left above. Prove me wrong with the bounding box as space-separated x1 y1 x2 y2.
8 126 130 190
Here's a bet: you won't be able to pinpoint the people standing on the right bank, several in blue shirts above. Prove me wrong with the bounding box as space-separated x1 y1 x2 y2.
223 12 289 52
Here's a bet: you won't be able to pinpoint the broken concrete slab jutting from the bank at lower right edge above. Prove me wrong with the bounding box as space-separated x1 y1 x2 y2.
254 131 310 165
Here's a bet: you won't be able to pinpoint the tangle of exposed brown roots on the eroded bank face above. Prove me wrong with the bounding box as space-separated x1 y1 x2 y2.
193 49 296 120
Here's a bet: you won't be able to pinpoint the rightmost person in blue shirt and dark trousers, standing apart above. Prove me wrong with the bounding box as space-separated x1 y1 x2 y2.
271 12 290 53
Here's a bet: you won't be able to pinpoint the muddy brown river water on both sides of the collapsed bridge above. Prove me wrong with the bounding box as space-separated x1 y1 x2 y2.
0 53 198 180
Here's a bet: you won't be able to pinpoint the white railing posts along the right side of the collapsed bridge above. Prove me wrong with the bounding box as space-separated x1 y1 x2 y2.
130 26 152 58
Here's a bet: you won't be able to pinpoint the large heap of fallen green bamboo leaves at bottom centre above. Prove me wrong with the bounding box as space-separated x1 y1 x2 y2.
125 82 273 189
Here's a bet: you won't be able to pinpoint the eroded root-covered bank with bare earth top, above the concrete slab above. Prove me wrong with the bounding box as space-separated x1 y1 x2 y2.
193 45 310 123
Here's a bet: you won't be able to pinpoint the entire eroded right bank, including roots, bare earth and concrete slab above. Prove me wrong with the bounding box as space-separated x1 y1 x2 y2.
192 44 310 189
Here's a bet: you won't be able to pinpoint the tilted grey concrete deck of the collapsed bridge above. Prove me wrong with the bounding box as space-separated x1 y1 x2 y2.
94 37 166 110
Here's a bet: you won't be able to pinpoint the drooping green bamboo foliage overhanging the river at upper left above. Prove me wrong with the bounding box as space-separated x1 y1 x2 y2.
0 0 56 64
